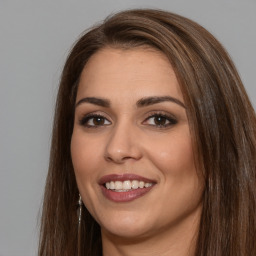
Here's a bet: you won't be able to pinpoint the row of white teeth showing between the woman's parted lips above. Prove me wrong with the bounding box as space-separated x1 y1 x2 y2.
105 180 153 192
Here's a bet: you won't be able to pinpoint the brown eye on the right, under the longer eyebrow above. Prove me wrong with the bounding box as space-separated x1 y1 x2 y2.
144 114 177 128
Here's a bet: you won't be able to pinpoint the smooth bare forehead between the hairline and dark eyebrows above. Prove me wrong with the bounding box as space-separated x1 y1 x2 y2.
77 48 182 100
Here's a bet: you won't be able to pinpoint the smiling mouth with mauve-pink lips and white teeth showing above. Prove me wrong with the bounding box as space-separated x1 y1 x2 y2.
100 174 156 202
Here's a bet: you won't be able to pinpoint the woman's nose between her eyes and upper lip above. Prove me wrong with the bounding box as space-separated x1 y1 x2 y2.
104 124 142 164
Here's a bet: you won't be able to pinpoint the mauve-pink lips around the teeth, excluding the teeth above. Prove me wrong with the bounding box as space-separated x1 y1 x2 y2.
99 173 156 203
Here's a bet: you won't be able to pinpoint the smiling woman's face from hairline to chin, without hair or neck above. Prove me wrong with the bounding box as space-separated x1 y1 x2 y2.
71 48 203 238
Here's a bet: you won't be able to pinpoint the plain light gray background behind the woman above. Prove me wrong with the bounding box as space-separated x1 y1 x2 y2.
0 0 256 256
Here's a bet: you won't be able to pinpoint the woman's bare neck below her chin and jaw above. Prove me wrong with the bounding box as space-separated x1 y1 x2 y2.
102 206 200 256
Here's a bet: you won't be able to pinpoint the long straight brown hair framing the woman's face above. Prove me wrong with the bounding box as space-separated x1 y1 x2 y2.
39 9 256 256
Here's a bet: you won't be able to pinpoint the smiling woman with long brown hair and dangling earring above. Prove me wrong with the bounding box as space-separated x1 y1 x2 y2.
39 10 256 256
